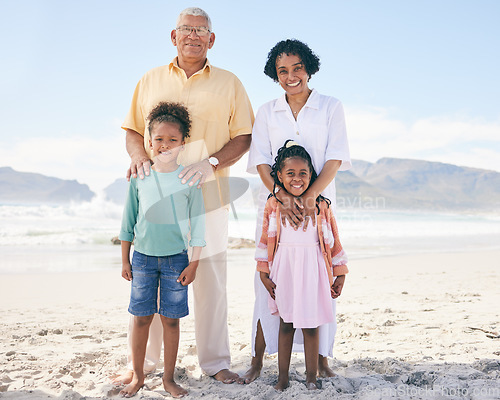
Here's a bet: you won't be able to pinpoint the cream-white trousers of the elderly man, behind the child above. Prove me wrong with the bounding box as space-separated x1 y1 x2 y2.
127 208 231 376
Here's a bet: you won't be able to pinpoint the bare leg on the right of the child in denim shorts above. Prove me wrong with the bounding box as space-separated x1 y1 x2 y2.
161 315 188 398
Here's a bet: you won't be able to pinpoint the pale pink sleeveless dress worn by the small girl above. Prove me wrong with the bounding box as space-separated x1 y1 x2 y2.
268 223 334 328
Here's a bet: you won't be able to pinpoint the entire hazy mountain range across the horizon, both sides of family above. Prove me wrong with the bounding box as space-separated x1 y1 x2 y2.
0 158 500 210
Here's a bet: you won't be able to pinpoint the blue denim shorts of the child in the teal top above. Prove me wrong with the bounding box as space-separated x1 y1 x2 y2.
128 251 189 318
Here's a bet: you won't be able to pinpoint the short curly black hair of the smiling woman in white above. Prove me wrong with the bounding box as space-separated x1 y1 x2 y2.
264 39 320 82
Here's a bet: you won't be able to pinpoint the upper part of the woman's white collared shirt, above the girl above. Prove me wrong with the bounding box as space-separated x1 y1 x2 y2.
247 89 351 209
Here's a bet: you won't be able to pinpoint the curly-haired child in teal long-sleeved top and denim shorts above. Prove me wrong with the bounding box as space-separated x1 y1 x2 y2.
119 103 205 397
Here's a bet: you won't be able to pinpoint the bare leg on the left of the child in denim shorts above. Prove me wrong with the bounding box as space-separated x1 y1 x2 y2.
120 315 154 397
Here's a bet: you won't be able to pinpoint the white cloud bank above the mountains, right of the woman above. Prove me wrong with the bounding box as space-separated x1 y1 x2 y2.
346 108 500 171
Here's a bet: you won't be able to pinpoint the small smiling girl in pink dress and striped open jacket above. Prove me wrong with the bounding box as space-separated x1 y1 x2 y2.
256 140 348 390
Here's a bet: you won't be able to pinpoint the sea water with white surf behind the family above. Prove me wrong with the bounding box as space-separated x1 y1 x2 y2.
0 197 500 274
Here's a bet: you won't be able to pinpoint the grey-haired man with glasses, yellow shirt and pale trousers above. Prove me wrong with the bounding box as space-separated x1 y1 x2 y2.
115 4 254 390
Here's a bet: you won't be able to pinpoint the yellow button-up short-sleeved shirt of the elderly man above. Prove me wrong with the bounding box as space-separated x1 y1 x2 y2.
122 57 254 211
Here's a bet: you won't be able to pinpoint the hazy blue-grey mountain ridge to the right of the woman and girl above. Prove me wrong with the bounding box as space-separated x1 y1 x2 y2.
337 158 500 209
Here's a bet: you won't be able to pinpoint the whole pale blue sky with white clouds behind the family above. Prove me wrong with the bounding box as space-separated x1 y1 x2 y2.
0 0 500 189
